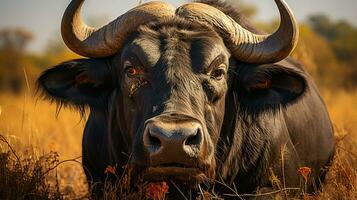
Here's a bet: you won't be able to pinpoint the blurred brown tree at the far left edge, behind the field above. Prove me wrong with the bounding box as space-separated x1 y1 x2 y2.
0 28 33 94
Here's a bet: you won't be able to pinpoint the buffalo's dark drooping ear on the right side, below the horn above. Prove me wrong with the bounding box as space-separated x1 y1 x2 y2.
236 61 307 111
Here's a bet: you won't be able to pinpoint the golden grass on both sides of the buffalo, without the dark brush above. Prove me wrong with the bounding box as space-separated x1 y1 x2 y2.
0 85 357 200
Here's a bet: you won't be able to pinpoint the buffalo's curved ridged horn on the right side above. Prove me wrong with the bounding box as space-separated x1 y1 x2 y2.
176 0 299 63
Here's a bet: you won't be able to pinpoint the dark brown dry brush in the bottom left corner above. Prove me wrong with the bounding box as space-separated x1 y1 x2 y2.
0 144 62 199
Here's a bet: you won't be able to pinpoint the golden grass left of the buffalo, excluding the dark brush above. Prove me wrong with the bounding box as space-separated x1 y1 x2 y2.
0 92 88 199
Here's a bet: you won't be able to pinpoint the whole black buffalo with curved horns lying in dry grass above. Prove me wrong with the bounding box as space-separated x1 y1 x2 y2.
38 0 335 198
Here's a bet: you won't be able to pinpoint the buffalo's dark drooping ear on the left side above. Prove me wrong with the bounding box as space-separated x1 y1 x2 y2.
37 59 114 106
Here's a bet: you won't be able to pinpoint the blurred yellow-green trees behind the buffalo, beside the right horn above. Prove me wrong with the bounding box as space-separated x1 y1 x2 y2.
255 15 357 88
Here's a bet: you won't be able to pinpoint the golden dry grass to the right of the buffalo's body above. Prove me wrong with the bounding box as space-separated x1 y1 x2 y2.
319 91 357 200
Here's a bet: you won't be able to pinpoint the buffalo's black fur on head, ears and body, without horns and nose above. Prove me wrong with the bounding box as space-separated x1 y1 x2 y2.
38 1 334 196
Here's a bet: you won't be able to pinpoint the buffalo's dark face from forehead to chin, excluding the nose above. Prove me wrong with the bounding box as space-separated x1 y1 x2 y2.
112 21 225 180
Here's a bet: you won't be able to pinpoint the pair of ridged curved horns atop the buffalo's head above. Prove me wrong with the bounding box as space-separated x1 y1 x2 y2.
61 0 298 63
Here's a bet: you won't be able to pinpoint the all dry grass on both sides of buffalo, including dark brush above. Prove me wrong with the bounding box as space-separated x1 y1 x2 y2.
0 87 357 199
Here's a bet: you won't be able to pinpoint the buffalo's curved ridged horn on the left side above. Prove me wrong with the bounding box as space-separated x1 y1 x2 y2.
61 0 175 58
